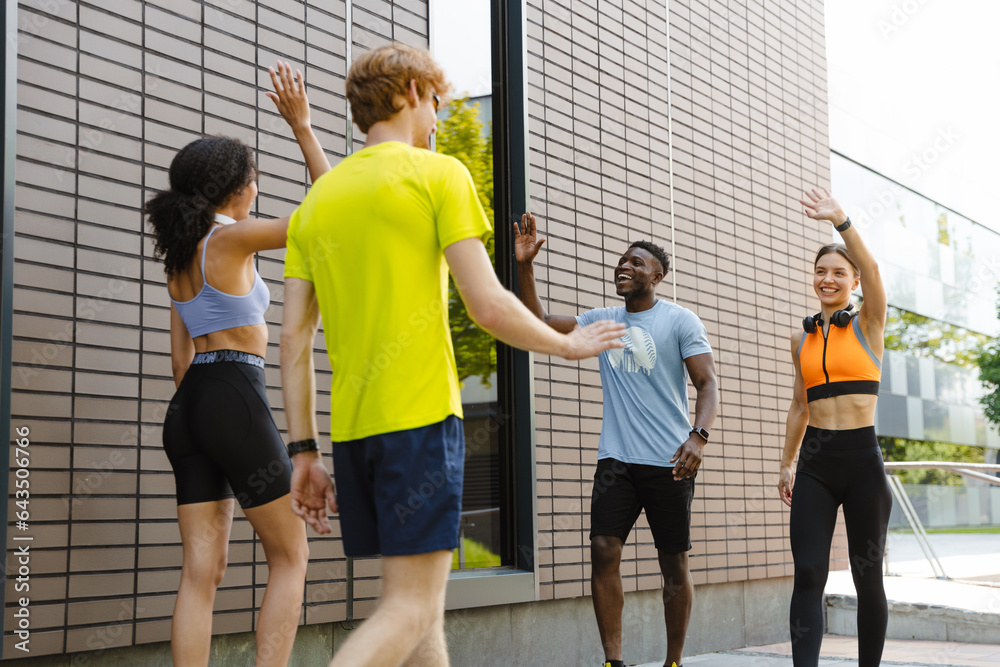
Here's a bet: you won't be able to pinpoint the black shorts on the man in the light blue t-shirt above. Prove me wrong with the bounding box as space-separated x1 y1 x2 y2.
590 459 694 553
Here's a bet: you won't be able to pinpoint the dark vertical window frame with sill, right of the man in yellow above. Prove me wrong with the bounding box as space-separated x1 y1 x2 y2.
446 0 538 609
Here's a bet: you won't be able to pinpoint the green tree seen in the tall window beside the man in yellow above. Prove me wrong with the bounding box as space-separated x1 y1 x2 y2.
437 98 497 384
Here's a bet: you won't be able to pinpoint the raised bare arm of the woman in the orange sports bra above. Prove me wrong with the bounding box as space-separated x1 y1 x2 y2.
799 188 888 347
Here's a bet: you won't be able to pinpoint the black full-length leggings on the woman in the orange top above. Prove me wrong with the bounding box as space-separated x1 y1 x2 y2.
789 426 892 667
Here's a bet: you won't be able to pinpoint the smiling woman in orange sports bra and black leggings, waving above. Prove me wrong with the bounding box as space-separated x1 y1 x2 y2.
778 190 892 667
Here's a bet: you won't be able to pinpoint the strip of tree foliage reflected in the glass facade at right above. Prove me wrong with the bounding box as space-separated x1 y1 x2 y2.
885 306 994 369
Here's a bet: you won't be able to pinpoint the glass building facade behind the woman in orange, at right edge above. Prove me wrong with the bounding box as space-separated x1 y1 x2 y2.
831 154 1000 446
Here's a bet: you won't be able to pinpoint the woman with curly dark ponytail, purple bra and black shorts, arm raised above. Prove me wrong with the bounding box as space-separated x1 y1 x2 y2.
145 62 330 667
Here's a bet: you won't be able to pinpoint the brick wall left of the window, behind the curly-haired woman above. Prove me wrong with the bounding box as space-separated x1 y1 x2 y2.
5 0 428 657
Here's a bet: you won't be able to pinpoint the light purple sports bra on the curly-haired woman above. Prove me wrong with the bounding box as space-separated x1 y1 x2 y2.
170 213 271 338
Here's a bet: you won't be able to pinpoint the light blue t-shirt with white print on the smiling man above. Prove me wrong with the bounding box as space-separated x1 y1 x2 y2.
576 300 712 467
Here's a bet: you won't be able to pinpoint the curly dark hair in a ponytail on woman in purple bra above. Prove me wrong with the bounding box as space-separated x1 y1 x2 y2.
143 137 259 276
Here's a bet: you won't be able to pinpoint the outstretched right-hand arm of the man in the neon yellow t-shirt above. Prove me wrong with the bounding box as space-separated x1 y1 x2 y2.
444 238 625 359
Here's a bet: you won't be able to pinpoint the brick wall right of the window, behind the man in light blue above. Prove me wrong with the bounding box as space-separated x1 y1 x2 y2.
528 0 842 598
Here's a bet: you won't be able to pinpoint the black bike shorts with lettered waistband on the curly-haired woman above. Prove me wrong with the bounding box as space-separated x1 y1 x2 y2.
163 350 292 508
